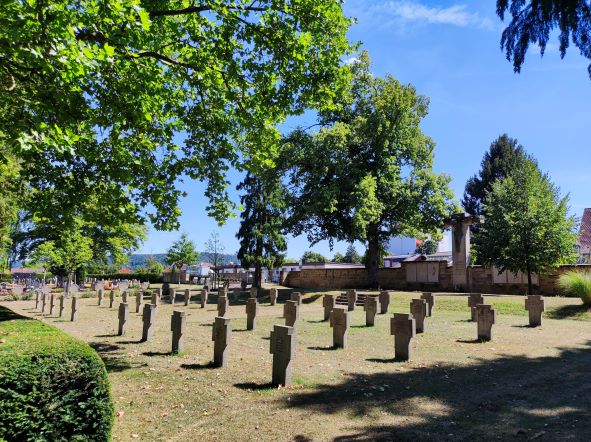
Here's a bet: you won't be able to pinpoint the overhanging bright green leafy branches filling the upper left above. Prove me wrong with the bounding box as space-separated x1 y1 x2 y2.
0 0 351 228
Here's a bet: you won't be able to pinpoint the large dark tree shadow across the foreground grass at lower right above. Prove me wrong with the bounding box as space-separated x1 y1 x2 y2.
279 341 591 441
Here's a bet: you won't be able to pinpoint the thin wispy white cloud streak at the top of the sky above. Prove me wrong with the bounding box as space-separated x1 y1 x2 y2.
353 0 493 28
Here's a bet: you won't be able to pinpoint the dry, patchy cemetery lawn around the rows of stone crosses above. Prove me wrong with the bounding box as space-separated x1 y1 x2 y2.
0 291 591 441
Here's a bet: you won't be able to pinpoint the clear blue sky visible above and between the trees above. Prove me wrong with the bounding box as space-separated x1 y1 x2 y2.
139 0 591 258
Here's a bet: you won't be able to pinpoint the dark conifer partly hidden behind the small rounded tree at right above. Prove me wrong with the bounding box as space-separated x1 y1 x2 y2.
462 134 527 218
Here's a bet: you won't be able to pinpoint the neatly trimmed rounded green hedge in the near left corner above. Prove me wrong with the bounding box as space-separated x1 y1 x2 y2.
0 307 114 441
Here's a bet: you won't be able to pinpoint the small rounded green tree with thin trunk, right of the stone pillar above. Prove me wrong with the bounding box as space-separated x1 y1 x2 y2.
476 161 577 295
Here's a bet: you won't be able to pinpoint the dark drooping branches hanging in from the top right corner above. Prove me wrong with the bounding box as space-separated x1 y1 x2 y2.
497 0 591 76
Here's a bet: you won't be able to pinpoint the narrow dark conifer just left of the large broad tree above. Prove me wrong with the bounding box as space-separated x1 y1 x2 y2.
236 171 287 289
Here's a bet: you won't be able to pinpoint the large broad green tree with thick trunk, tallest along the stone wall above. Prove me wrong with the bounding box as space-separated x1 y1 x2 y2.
285 53 454 287
